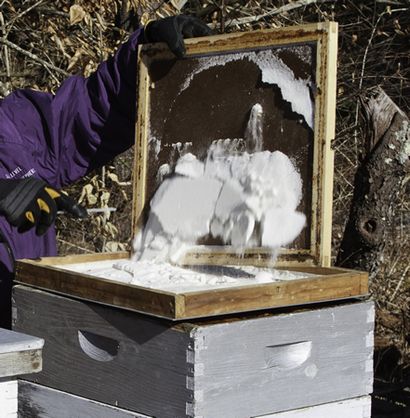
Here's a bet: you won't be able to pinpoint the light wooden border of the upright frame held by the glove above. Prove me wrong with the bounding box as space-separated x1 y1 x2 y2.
133 22 337 267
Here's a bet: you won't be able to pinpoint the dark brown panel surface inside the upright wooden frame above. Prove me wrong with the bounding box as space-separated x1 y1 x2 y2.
146 44 316 248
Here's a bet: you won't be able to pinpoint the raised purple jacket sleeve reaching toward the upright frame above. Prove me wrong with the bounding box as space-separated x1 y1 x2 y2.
0 30 141 188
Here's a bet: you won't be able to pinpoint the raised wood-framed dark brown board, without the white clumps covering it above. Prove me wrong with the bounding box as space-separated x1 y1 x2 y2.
133 24 336 266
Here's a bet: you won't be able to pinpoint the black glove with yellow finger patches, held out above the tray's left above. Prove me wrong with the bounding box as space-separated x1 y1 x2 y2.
0 177 87 235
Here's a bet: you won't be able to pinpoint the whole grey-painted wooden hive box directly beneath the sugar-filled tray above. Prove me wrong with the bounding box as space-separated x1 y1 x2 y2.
14 286 374 418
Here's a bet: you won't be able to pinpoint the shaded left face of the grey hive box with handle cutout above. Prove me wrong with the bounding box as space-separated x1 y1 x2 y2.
13 286 190 417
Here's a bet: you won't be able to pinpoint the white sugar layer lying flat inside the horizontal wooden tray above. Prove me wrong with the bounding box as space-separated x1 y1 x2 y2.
56 260 311 293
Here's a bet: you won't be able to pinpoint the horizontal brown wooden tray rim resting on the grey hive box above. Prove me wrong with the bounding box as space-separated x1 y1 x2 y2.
16 252 368 320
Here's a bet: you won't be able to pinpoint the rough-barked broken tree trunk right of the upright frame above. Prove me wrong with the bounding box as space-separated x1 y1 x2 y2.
337 87 410 274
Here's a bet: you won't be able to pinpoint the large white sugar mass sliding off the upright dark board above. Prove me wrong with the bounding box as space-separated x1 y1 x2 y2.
133 104 305 263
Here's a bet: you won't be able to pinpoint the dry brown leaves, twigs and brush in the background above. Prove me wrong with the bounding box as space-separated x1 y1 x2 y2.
0 0 410 416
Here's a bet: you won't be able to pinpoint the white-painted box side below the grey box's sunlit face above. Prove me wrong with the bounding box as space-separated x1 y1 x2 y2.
255 396 371 418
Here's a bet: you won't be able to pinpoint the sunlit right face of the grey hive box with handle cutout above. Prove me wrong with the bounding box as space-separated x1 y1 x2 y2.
191 302 374 418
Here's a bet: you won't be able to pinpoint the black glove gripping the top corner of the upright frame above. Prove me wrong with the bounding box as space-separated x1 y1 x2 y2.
144 15 211 58
